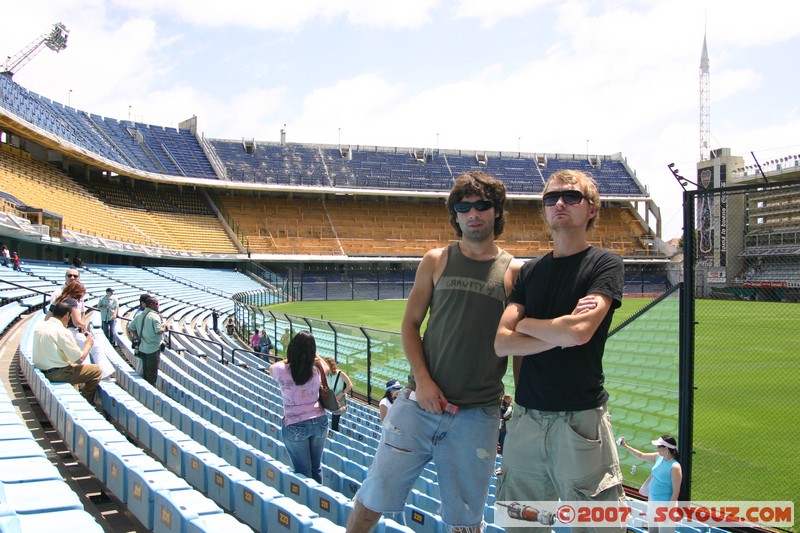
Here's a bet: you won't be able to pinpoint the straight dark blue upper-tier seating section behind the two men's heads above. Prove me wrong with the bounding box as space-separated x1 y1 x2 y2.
208 139 646 196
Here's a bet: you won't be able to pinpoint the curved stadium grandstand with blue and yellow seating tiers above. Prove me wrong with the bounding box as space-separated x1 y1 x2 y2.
0 75 800 533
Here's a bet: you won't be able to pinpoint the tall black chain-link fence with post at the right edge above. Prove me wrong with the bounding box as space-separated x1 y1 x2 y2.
680 178 800 531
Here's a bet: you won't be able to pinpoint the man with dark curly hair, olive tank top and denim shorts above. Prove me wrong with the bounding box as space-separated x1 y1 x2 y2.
347 171 520 532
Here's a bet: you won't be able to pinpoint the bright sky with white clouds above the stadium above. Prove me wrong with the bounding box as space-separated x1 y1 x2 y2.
0 0 800 240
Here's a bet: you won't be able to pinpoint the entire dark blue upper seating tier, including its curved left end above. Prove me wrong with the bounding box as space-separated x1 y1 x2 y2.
0 76 647 196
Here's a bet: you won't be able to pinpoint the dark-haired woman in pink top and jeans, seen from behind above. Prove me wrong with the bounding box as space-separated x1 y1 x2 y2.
269 331 328 483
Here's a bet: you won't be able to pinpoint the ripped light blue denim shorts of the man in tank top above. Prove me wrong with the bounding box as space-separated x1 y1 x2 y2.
356 391 500 527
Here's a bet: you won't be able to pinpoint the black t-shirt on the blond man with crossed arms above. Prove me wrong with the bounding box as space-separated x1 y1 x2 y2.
510 246 625 411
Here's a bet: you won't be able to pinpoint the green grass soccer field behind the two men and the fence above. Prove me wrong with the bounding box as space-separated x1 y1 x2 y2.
270 299 800 524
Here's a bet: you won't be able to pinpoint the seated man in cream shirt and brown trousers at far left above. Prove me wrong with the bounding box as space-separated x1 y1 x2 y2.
33 301 103 404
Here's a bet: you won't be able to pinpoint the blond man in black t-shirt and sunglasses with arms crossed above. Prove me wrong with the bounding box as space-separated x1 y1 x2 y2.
495 171 624 528
